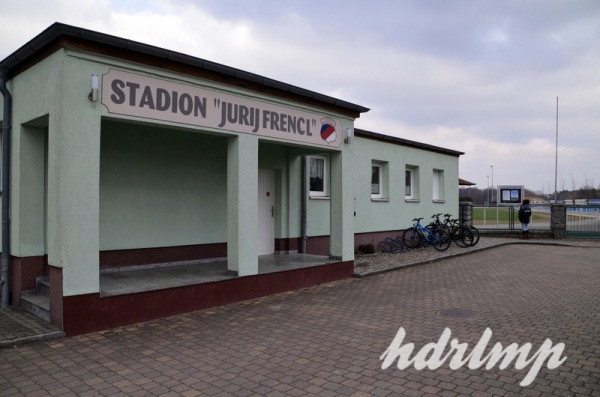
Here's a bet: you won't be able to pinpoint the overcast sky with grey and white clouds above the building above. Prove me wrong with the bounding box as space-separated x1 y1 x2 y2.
0 0 600 193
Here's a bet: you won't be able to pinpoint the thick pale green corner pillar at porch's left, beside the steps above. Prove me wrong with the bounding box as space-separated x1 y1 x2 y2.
47 100 101 296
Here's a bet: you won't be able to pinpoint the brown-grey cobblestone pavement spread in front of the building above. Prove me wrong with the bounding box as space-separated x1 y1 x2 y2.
0 240 600 397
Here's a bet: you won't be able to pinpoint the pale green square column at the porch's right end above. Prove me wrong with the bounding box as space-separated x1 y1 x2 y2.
329 148 354 261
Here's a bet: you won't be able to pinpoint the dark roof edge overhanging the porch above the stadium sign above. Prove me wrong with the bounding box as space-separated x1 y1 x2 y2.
0 22 370 118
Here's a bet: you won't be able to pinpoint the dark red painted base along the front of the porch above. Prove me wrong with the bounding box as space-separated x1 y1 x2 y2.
62 261 354 336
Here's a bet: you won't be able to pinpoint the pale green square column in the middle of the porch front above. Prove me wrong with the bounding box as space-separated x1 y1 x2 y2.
227 134 258 276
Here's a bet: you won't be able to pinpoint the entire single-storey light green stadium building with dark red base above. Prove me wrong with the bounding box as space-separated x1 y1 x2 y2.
0 23 462 335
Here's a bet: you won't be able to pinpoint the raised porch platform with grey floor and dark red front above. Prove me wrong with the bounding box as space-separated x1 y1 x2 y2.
58 254 354 336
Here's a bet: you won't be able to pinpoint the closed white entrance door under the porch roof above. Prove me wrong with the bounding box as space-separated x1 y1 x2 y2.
258 170 275 255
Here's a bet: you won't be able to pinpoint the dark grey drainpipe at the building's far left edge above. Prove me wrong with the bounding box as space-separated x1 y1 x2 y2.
0 70 12 307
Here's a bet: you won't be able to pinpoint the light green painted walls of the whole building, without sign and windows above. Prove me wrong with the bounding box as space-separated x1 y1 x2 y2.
0 41 458 296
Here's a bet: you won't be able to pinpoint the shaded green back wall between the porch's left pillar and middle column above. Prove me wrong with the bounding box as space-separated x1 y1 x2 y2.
100 121 227 250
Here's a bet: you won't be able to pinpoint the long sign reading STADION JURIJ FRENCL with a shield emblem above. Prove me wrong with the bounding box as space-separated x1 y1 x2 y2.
102 69 343 148
